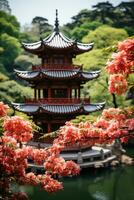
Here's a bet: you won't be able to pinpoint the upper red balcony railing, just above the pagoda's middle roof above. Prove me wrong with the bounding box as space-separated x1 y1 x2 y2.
32 64 82 71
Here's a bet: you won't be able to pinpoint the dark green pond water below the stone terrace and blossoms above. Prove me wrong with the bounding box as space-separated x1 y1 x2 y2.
15 148 134 200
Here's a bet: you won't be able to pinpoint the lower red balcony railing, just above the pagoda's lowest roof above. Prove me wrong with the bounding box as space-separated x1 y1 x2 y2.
25 98 90 105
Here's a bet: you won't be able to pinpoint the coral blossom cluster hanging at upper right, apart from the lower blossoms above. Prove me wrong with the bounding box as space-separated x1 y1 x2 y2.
106 39 134 95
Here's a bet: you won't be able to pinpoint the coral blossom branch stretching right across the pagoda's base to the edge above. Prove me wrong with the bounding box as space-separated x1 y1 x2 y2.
55 108 134 147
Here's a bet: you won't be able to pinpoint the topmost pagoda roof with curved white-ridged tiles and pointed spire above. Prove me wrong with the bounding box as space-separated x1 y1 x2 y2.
22 10 93 54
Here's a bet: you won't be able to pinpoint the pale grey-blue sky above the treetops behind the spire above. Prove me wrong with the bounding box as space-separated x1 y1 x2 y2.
8 0 127 25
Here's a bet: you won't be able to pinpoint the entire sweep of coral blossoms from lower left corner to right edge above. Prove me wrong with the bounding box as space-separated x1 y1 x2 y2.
0 101 134 200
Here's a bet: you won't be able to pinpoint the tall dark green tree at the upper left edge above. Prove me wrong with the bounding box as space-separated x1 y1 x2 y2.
0 11 21 73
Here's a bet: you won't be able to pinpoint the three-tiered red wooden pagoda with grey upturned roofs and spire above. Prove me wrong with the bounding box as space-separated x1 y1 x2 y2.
13 10 105 133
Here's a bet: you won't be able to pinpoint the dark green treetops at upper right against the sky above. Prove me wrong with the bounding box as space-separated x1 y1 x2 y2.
64 1 134 40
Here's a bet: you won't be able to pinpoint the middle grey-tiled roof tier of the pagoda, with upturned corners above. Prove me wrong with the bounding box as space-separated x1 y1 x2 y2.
14 69 100 81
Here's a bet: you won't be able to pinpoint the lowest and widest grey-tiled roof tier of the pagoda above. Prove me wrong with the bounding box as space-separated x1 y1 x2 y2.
12 102 105 114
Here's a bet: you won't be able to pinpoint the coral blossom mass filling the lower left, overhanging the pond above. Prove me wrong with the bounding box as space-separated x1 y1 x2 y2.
0 102 80 200
